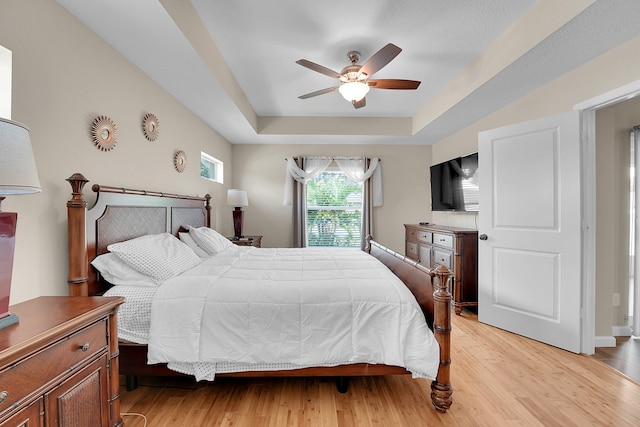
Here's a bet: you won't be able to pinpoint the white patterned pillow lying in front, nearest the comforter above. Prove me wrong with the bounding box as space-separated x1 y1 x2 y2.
107 233 202 282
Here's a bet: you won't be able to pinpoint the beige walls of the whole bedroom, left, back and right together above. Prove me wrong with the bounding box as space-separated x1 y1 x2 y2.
0 0 640 344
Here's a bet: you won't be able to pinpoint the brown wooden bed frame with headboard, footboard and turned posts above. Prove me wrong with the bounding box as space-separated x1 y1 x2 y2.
67 173 452 413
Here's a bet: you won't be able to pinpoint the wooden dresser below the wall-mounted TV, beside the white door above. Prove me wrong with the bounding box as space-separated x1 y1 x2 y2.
404 224 478 315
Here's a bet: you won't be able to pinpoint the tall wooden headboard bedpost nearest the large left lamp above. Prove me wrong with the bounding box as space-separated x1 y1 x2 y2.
66 173 89 296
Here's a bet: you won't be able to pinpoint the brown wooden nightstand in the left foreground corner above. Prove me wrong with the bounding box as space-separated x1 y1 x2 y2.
0 297 124 427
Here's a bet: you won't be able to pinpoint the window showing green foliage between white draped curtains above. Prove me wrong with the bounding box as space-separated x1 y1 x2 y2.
307 167 362 248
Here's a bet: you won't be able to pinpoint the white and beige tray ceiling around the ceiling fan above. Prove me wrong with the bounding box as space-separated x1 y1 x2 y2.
58 0 640 144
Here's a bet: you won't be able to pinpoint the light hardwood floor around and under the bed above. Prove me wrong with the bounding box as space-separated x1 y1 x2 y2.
121 312 640 427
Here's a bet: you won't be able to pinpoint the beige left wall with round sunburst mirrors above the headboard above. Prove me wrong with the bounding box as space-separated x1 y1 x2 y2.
0 0 232 304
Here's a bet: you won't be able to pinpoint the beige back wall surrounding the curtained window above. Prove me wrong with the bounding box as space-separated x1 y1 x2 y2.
233 143 431 253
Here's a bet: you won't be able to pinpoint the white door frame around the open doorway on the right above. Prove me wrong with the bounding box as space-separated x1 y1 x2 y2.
573 80 640 354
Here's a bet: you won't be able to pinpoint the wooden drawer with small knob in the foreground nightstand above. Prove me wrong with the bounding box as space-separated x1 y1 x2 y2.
0 320 108 416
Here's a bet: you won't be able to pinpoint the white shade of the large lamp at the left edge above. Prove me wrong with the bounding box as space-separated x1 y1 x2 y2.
0 118 42 196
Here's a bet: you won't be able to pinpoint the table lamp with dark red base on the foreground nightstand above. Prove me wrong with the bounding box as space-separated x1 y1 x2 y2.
0 118 42 329
